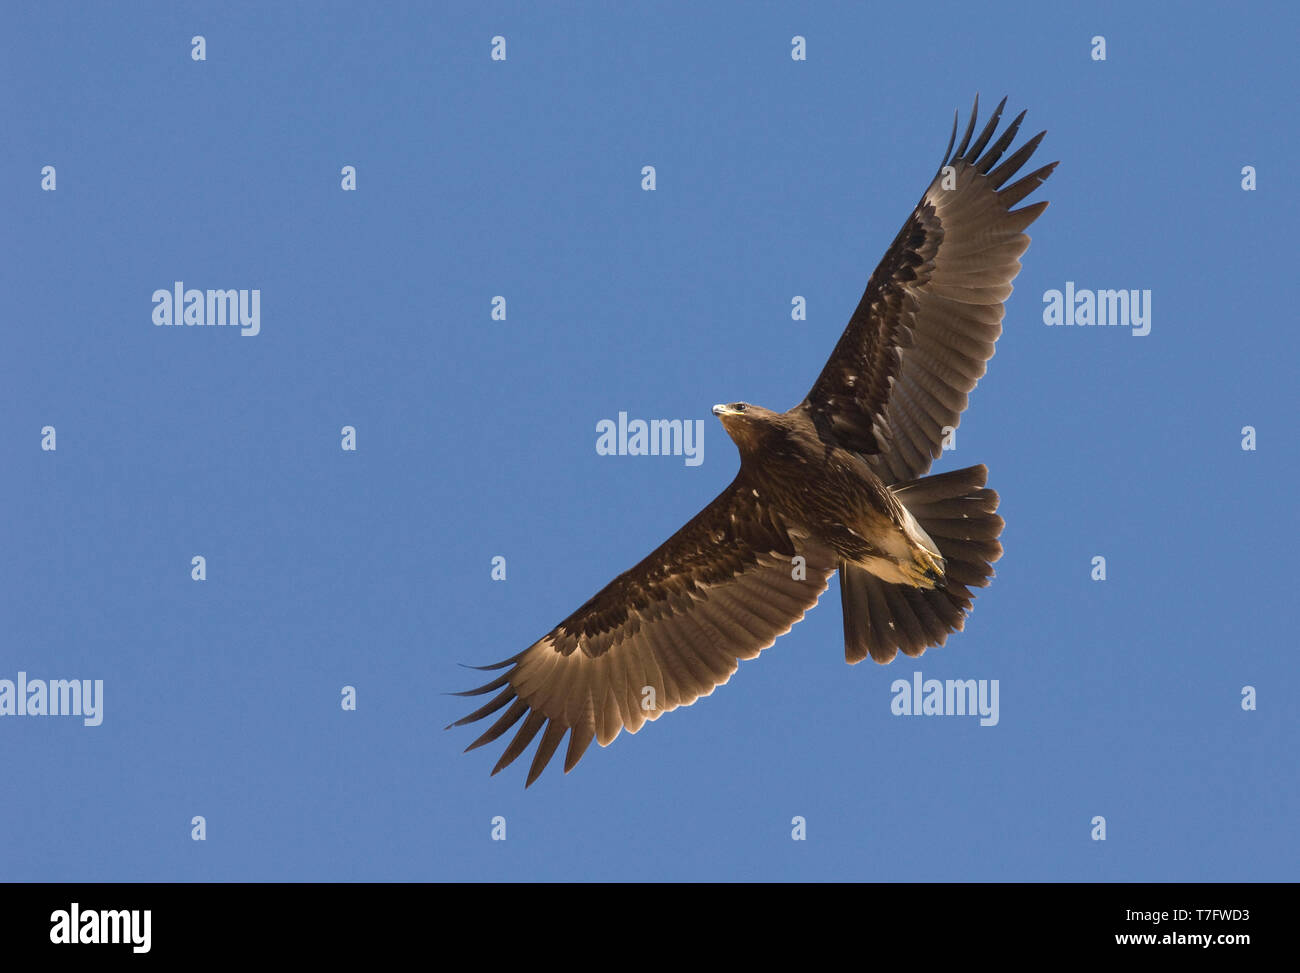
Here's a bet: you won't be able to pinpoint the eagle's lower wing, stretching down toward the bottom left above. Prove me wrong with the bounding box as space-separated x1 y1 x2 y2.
452 472 835 784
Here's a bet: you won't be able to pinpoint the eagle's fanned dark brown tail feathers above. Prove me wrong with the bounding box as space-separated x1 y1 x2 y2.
840 466 1002 663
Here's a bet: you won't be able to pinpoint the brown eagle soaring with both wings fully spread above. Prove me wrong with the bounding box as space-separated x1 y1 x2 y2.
447 95 1057 787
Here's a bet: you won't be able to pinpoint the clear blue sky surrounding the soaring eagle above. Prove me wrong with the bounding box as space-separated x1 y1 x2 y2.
0 3 1300 881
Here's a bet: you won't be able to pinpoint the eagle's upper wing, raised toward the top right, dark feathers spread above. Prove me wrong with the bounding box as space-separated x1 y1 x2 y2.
797 98 1056 484
